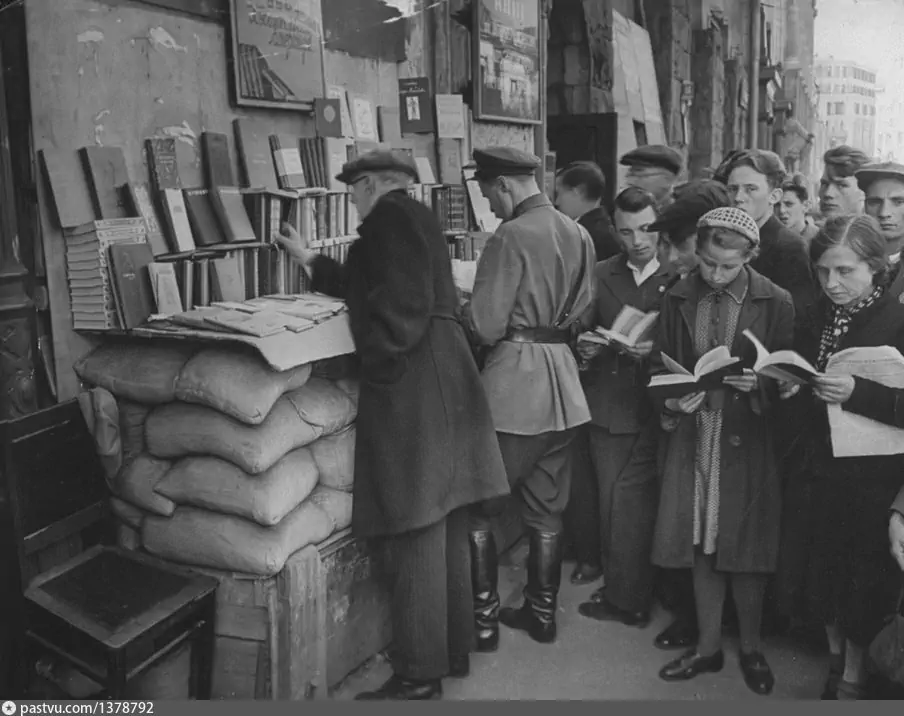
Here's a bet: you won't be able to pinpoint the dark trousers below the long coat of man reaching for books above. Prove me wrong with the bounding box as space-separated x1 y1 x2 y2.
380 508 476 679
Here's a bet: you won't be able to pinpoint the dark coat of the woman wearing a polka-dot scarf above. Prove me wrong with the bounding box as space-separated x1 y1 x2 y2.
777 289 904 647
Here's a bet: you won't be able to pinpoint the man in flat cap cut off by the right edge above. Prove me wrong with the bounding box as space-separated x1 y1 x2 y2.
855 162 904 296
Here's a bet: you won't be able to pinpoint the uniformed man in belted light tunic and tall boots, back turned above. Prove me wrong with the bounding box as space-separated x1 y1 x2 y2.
465 147 595 651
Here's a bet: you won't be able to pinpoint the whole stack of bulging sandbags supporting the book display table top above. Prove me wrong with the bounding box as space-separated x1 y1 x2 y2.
76 342 357 576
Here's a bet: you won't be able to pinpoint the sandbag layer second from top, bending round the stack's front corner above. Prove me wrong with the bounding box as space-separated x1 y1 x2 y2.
144 378 355 475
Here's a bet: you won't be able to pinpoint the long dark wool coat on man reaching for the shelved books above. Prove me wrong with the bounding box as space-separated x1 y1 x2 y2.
312 191 509 536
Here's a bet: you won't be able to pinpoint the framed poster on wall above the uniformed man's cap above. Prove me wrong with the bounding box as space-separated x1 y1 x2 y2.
472 0 542 124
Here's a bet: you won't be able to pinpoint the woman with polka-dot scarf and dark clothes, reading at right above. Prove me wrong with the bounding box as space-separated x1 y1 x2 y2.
779 215 904 700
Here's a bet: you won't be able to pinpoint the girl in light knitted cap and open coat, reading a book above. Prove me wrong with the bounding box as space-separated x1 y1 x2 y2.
652 207 794 694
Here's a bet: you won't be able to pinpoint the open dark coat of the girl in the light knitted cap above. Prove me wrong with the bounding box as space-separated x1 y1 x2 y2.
653 267 794 572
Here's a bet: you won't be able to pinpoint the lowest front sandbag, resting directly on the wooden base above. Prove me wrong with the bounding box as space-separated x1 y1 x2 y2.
141 499 333 577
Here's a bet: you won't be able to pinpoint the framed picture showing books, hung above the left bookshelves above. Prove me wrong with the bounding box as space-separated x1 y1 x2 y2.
229 0 324 112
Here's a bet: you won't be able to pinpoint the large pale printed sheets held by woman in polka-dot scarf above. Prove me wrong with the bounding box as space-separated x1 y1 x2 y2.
826 346 904 457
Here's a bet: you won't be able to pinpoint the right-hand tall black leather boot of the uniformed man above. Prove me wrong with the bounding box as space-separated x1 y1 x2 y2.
499 529 563 644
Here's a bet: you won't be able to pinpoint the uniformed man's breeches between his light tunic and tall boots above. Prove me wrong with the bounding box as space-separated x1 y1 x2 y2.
471 429 576 533
